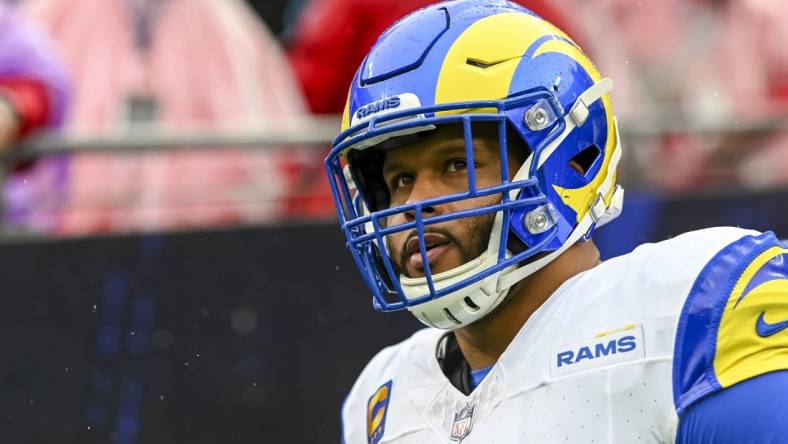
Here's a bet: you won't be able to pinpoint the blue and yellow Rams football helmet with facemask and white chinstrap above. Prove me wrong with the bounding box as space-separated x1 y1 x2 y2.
325 0 623 329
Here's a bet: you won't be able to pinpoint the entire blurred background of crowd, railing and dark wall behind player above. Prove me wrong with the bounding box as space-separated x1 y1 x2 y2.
0 0 788 444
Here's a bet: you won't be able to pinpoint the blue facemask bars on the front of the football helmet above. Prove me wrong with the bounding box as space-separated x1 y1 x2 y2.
326 90 565 311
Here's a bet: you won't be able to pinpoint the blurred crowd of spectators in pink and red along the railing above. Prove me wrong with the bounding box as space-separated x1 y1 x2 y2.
0 0 788 235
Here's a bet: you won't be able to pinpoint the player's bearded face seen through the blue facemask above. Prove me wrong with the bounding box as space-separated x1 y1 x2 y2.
383 126 524 278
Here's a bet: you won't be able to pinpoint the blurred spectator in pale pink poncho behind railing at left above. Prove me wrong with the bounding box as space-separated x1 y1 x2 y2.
24 0 319 235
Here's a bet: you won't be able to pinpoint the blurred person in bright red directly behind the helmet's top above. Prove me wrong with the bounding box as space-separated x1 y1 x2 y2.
288 0 583 114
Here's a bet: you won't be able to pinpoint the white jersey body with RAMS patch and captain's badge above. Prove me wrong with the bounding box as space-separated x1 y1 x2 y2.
342 228 772 444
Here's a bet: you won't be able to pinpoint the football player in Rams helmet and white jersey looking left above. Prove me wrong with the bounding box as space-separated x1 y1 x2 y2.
326 0 788 444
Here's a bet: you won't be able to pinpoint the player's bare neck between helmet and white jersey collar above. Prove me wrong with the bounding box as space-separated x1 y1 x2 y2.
454 241 599 370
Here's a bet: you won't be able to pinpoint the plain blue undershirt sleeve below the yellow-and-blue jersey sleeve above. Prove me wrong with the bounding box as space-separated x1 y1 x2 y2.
676 371 788 444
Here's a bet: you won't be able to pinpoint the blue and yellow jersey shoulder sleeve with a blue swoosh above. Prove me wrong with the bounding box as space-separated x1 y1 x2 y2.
673 233 788 414
